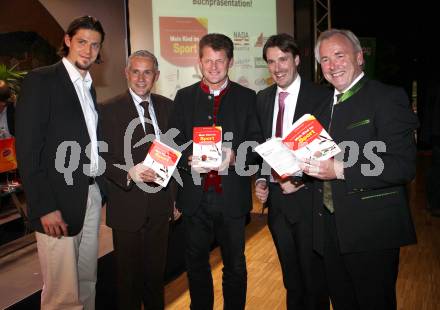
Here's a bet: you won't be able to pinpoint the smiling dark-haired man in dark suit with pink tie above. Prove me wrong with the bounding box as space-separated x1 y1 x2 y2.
256 34 331 309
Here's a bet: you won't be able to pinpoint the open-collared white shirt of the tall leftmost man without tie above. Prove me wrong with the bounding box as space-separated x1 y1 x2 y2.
62 57 99 176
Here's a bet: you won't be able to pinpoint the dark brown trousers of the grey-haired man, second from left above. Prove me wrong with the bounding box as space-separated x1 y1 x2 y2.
113 215 169 310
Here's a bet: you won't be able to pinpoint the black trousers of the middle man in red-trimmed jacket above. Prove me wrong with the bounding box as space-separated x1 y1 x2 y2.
184 191 247 310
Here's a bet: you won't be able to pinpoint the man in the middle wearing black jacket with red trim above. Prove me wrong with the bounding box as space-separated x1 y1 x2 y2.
170 34 260 310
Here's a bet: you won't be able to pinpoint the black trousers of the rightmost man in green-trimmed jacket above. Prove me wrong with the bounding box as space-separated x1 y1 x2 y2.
323 206 399 310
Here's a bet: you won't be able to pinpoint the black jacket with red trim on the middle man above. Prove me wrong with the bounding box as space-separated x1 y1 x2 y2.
170 81 261 217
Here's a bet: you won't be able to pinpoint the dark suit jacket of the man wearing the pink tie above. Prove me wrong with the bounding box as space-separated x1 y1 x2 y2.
257 79 332 222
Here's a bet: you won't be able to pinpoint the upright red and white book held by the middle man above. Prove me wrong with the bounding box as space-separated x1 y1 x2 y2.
192 126 222 169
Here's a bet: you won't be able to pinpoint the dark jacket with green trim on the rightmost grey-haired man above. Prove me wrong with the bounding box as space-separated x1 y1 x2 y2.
314 79 418 253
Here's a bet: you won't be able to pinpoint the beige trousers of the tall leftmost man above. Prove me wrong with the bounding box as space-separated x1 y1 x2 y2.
36 183 101 310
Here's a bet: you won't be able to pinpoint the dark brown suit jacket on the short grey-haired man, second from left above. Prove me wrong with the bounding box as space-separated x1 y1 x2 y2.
101 91 175 232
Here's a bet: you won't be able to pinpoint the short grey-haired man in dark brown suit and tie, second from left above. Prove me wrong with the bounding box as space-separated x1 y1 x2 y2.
102 50 174 310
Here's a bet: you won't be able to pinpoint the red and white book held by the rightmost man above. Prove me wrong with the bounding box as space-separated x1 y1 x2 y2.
283 114 341 160
